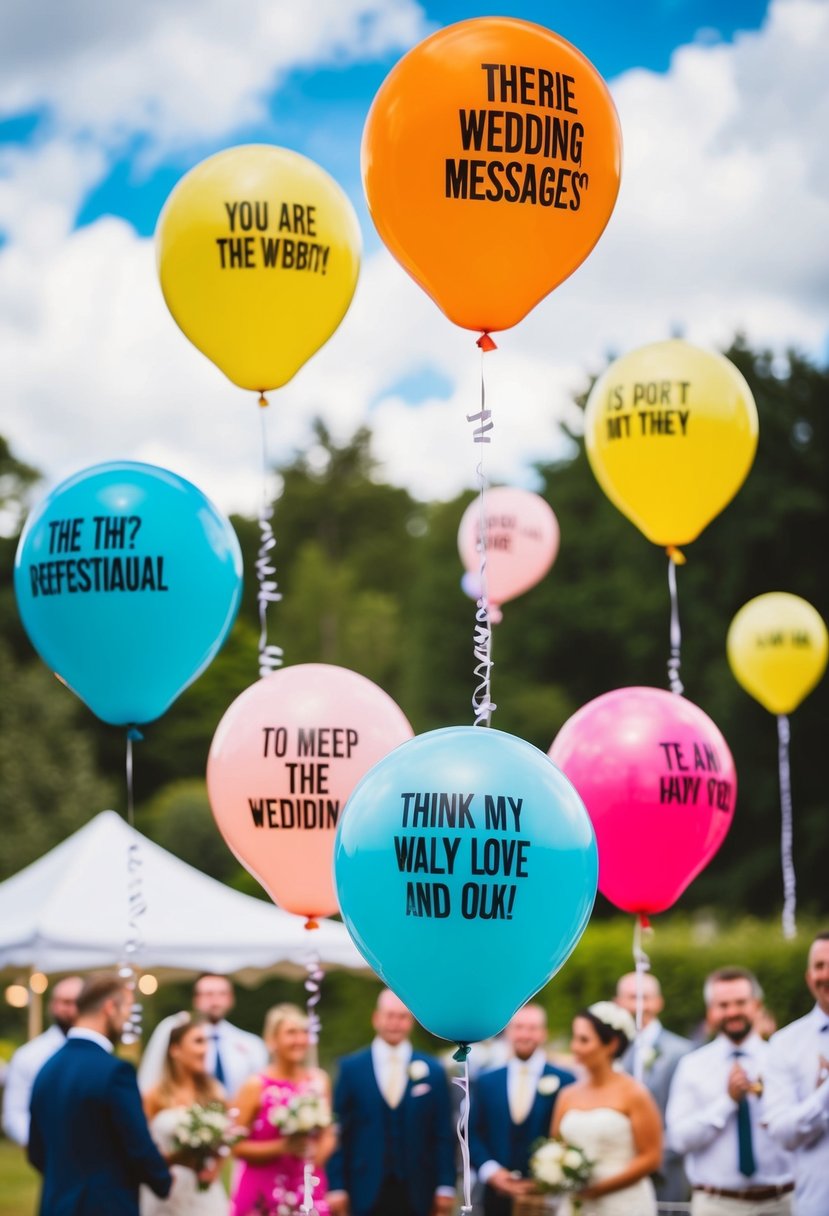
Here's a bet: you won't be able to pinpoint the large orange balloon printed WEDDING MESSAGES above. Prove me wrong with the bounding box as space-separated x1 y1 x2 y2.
362 17 621 332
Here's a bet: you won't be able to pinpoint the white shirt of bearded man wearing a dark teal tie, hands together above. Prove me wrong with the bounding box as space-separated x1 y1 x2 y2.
665 1034 792 1191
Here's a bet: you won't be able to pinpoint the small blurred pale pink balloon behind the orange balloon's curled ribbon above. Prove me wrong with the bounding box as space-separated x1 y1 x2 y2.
458 485 559 604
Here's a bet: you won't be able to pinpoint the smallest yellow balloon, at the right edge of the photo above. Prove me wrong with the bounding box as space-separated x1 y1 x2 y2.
726 591 829 714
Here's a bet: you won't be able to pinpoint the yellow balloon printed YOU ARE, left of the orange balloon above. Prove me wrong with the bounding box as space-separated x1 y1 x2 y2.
156 143 361 393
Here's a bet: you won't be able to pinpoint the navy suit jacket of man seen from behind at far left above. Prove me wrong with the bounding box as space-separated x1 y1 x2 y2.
28 1038 173 1216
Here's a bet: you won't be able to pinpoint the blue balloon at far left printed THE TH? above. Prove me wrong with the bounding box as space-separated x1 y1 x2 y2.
15 461 242 726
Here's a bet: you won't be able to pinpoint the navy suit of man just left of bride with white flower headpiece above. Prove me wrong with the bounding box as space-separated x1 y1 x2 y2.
469 1064 575 1212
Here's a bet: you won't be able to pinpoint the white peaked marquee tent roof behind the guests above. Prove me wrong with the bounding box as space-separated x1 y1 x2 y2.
0 811 370 984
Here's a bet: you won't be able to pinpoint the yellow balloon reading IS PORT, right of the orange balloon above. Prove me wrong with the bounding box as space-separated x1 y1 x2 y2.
585 338 757 546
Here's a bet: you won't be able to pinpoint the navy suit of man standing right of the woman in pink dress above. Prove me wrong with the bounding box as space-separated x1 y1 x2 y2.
326 1048 456 1216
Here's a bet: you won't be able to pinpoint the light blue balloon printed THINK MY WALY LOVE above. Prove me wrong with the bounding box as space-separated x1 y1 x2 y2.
334 726 598 1043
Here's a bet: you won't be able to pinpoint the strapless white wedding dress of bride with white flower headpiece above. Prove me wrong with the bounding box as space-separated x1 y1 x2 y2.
559 1107 656 1216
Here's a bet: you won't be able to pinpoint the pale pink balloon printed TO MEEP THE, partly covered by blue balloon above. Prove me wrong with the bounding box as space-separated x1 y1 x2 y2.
207 663 412 921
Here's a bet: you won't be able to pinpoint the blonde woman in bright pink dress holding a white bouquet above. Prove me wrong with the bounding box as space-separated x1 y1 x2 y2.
231 1004 335 1216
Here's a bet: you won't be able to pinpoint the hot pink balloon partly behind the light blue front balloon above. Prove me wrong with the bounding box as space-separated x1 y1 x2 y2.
549 688 737 914
